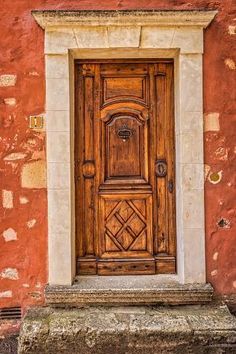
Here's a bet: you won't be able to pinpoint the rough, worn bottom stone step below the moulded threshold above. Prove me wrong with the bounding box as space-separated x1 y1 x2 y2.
18 304 236 354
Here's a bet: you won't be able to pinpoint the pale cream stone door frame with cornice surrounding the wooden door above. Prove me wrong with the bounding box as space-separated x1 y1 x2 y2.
32 10 216 285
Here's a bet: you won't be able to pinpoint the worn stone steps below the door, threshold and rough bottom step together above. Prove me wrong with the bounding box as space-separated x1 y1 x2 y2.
19 277 236 354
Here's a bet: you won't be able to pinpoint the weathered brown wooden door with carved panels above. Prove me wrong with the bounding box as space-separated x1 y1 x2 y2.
75 60 175 275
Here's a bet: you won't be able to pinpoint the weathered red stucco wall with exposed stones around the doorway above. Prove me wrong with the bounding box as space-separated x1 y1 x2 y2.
0 0 236 307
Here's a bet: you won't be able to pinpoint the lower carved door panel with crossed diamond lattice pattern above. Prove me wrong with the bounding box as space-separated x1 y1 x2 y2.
100 195 152 257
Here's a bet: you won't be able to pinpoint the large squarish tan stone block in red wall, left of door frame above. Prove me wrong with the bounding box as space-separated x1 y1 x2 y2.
21 160 47 189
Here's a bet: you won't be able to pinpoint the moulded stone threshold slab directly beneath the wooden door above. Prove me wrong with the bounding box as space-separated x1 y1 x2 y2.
45 275 213 306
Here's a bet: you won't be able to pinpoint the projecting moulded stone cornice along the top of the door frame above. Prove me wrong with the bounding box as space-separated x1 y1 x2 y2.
32 10 217 29
